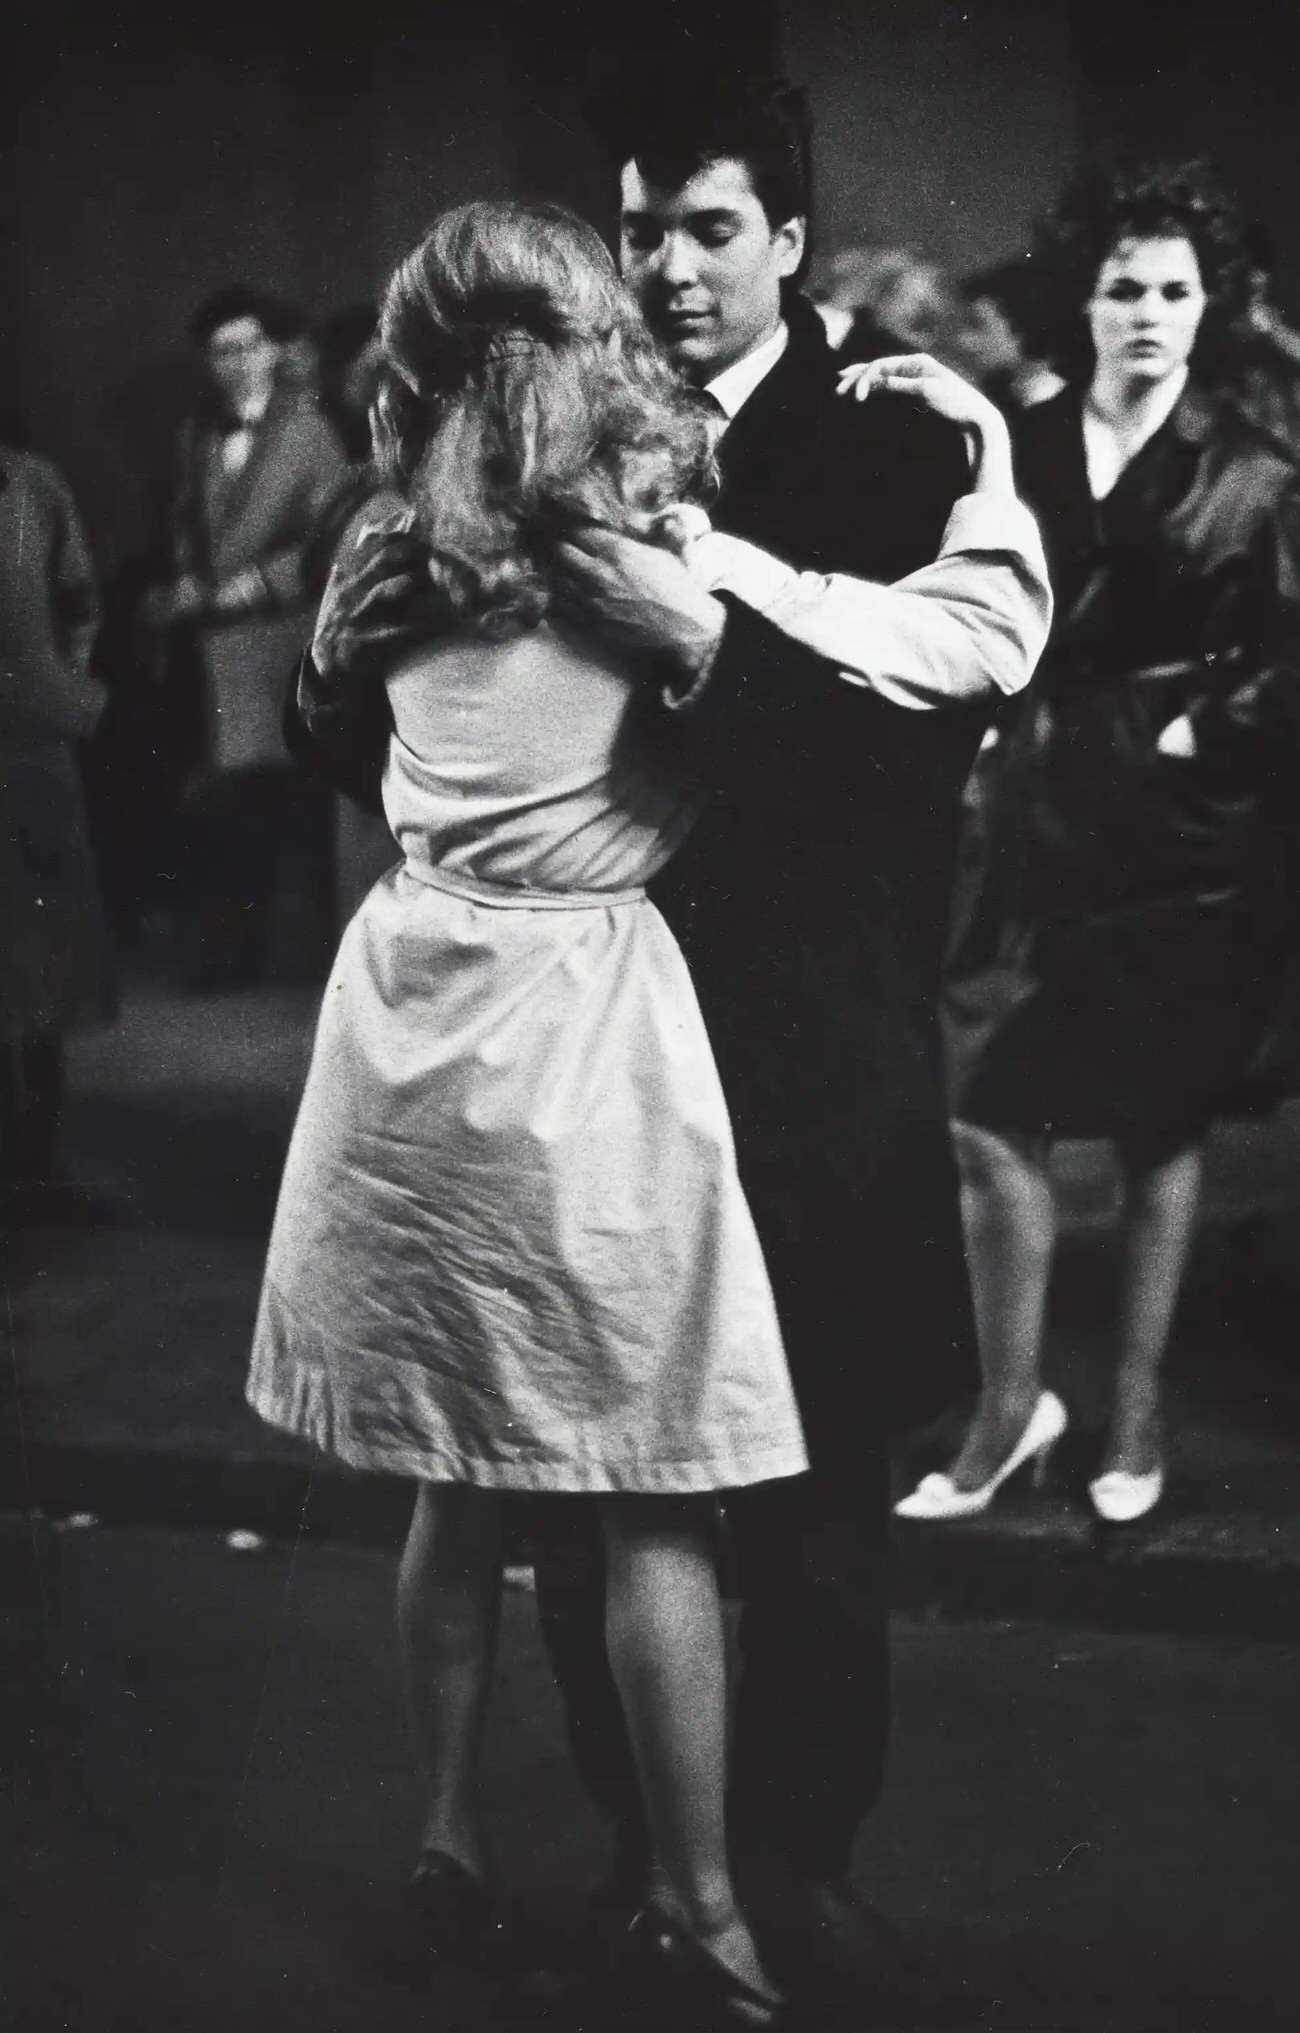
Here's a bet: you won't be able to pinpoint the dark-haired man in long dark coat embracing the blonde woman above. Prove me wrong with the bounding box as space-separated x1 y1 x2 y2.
294 79 1017 2003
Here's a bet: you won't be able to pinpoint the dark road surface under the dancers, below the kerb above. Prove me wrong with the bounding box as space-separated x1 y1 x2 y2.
0 1517 1300 2033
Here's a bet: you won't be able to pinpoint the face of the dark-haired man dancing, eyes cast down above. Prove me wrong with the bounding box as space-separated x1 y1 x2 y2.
618 157 804 386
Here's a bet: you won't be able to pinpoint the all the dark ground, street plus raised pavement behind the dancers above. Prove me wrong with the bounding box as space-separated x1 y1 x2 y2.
0 978 1300 2033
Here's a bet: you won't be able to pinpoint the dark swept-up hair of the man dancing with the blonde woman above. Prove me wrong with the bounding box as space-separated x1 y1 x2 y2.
586 69 812 276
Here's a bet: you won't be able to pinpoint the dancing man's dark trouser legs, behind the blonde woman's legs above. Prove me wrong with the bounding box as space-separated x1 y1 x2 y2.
537 1454 889 1876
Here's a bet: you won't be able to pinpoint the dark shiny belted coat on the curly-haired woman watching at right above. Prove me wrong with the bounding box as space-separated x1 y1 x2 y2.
948 388 1300 1157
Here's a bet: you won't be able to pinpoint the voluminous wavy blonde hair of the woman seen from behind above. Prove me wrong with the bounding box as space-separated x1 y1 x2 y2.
372 201 712 632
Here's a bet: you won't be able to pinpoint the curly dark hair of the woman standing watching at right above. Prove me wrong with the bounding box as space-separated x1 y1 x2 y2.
1023 152 1251 386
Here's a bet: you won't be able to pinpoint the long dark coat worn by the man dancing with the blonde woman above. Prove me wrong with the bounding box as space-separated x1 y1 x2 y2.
295 301 987 1470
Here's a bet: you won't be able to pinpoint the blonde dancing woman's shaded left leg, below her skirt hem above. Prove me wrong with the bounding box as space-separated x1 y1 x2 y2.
397 1484 505 1876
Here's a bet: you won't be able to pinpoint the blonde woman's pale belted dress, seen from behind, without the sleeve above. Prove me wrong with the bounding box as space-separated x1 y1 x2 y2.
248 624 806 1492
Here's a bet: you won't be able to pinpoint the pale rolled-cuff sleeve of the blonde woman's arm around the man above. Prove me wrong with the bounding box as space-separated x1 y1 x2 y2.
686 494 1052 710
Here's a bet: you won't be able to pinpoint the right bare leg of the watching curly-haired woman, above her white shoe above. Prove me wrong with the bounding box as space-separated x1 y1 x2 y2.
1103 1145 1202 1476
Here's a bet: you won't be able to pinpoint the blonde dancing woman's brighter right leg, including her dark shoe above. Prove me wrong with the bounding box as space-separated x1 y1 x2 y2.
602 1496 775 1996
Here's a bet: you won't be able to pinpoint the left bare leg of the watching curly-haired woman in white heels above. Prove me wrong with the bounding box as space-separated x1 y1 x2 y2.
950 1122 1056 1490
